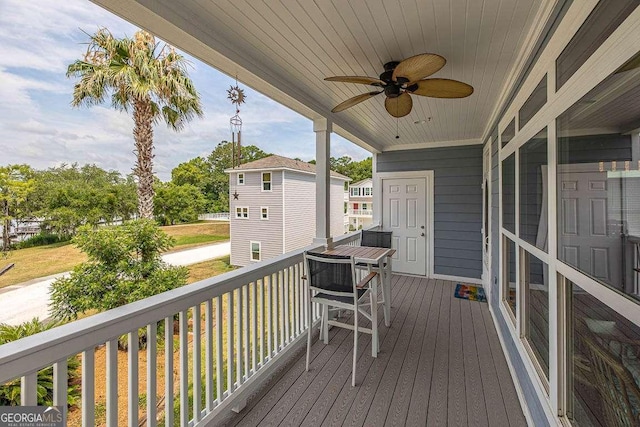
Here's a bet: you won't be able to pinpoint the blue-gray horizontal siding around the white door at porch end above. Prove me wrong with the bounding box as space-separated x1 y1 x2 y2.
377 145 482 279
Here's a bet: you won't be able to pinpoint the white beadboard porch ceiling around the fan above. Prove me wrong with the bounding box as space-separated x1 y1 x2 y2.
94 0 555 151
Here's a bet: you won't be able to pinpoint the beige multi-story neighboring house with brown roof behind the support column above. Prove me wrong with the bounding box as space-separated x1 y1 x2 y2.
225 155 349 266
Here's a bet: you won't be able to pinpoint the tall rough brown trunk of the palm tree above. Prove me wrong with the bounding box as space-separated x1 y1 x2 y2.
133 100 154 219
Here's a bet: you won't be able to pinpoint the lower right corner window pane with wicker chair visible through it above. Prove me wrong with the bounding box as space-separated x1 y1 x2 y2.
568 284 640 426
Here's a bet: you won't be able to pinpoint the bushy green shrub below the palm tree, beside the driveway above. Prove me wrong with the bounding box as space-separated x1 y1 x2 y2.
51 219 188 320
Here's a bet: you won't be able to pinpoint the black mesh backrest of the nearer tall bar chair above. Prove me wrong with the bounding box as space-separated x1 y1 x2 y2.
304 252 356 295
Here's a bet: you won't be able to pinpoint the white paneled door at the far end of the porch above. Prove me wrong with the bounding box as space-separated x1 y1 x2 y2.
382 178 428 276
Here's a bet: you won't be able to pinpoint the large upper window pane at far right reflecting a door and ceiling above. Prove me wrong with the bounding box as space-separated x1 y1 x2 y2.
557 51 640 299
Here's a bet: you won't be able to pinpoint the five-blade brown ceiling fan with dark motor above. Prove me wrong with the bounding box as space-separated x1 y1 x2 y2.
325 53 473 117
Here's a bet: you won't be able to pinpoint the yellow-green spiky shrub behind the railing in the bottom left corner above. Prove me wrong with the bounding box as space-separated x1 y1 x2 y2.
0 318 80 407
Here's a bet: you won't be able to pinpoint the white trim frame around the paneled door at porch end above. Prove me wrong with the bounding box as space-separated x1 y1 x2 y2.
373 170 434 277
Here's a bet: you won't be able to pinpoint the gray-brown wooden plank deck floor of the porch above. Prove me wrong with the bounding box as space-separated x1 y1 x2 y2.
216 276 526 427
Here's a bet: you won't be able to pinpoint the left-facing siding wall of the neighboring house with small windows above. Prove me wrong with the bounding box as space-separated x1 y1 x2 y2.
229 171 283 266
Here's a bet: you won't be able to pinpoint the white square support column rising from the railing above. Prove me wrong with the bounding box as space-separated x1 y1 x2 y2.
313 117 332 246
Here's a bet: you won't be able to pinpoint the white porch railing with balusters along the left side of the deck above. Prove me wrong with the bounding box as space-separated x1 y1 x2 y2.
0 232 360 426
